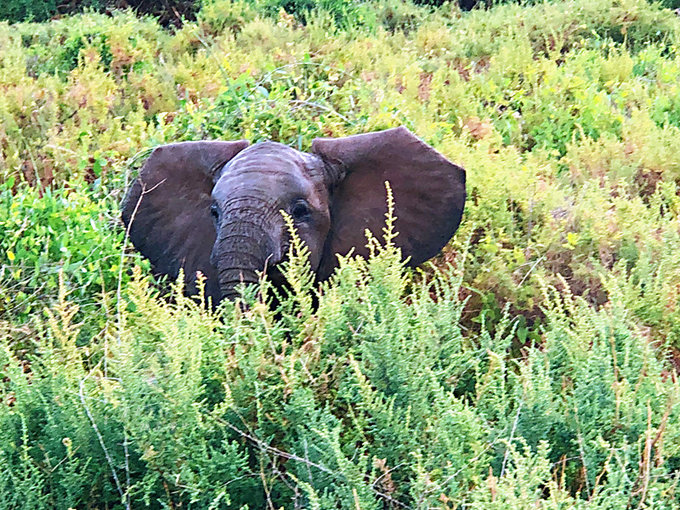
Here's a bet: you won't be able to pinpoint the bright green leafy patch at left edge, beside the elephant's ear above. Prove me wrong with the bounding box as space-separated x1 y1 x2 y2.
0 181 139 318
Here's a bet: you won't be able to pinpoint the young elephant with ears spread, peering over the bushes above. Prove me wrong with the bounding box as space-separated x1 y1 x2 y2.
123 127 465 304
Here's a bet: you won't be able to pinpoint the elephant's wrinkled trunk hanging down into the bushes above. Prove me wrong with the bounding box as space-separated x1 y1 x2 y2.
212 203 280 300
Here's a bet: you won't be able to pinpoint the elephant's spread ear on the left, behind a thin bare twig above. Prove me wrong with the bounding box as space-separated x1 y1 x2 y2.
122 140 248 303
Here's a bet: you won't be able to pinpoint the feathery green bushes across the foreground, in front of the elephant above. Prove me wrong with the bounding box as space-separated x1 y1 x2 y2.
0 233 680 509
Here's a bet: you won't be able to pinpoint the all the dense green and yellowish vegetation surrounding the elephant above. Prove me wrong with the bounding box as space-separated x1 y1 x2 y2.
0 0 680 510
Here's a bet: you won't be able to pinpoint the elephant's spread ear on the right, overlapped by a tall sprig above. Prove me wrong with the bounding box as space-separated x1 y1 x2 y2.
312 127 465 278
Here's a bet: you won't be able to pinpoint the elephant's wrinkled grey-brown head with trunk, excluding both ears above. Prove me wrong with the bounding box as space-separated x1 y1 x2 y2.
210 142 331 299
